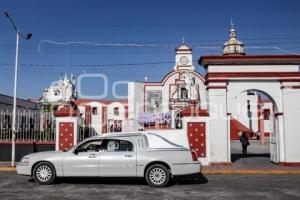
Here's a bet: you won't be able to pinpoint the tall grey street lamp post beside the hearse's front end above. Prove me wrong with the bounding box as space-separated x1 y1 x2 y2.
4 11 32 166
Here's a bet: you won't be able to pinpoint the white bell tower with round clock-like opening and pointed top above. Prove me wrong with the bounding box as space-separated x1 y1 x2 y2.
174 38 195 70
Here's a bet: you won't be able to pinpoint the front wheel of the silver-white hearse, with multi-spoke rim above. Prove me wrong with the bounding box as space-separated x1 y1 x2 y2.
33 162 56 185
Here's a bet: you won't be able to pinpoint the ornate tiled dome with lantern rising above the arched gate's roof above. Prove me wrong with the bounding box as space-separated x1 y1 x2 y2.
223 28 245 55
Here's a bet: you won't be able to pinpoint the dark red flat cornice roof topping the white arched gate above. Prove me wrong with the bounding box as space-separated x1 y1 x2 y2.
198 55 300 67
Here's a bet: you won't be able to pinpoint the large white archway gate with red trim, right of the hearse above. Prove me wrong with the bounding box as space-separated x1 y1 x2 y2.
199 55 300 165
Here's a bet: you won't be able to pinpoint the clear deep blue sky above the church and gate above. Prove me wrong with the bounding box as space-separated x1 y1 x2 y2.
0 0 300 99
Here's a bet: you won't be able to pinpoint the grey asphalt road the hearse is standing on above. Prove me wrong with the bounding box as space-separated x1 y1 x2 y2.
0 173 300 200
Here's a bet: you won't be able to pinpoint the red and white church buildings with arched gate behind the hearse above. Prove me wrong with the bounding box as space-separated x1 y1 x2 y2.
49 28 300 165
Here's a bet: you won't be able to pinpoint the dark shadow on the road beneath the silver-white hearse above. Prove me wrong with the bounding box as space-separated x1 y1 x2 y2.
28 173 208 186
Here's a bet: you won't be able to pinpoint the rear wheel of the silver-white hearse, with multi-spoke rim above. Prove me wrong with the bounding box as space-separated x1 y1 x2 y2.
145 164 170 187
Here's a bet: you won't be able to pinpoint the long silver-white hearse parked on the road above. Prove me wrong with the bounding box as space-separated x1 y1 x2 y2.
17 132 201 187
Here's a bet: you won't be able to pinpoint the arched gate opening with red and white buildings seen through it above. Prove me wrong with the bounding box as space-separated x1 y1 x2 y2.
230 90 279 167
